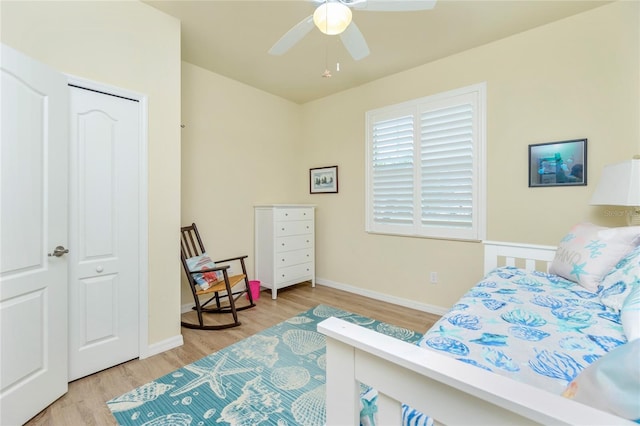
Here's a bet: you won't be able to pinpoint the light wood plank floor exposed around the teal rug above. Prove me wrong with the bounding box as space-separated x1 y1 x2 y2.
27 283 439 425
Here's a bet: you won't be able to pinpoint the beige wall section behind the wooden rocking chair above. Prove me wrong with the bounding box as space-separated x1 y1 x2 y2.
182 62 308 304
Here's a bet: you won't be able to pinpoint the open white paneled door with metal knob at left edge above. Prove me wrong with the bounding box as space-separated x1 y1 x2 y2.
0 45 69 425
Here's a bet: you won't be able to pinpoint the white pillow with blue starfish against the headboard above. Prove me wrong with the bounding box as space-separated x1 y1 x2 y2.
549 223 640 292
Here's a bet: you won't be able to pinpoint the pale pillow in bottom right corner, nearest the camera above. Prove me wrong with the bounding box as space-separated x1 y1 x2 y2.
562 339 640 422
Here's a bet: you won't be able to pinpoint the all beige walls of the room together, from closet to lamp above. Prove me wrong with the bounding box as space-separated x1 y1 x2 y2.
6 1 640 343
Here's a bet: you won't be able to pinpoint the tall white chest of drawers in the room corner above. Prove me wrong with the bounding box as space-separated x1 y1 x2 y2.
254 204 316 299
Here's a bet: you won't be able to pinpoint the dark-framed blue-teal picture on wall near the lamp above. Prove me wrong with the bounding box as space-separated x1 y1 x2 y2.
529 139 587 187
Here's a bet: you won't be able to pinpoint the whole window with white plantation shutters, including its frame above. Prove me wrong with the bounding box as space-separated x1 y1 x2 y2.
366 83 486 240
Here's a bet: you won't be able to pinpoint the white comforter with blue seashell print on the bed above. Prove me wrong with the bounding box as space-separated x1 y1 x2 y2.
418 267 626 394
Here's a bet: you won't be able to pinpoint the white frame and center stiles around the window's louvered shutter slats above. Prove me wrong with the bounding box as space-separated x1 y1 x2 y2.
365 82 487 241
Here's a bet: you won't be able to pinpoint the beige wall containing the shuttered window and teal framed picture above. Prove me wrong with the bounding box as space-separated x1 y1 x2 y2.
296 2 640 307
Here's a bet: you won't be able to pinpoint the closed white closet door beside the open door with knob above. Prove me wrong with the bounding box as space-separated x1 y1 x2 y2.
69 87 141 380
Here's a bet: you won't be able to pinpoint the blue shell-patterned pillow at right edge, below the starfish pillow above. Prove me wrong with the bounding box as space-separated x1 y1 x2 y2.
600 246 640 313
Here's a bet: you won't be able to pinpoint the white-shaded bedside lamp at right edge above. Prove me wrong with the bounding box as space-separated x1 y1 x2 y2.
589 155 640 226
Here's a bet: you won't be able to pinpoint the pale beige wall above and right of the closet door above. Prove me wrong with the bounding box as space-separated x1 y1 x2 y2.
1 1 180 344
